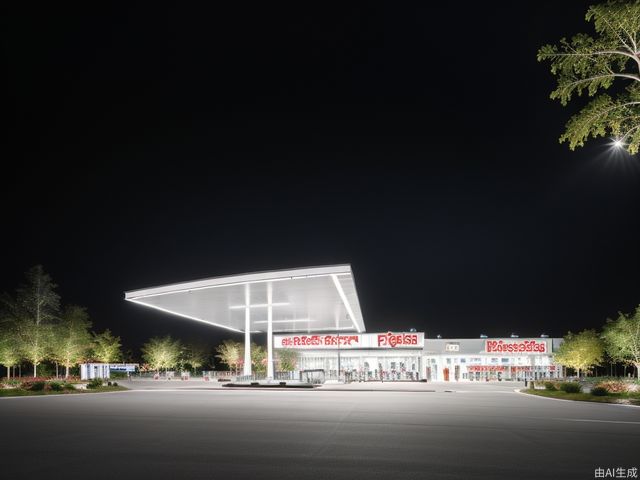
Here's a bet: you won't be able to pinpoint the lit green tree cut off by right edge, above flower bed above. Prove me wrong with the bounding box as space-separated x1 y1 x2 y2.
602 306 640 380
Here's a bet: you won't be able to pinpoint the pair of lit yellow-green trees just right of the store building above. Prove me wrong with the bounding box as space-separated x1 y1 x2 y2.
554 306 640 380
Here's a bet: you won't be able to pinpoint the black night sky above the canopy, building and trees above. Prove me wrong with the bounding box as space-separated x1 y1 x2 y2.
0 1 640 350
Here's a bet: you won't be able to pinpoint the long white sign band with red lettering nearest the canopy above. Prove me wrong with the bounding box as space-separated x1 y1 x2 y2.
273 332 424 350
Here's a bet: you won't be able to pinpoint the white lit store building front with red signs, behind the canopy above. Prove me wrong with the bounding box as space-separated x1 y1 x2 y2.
273 332 562 382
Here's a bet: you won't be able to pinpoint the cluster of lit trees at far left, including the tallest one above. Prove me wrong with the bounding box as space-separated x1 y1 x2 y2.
0 265 122 377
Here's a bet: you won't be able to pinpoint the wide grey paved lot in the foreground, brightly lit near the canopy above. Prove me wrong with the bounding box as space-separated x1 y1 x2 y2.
0 383 640 480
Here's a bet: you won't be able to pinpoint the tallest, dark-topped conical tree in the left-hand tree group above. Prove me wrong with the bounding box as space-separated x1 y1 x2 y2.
3 265 60 377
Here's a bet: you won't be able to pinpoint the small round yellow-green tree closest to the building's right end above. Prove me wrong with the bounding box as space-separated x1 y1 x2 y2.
554 330 604 378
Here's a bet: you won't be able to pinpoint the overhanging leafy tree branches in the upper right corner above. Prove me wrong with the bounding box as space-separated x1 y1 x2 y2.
538 0 640 154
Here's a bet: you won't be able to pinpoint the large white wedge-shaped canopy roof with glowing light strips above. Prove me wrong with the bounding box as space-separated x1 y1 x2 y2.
125 265 365 333
